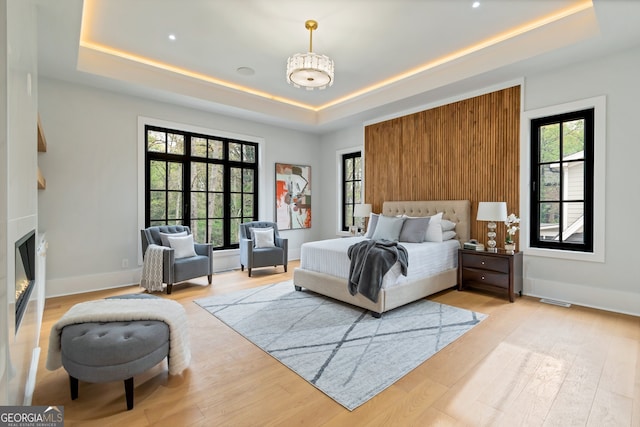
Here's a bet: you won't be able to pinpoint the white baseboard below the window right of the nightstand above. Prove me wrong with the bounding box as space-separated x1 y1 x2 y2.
523 278 640 316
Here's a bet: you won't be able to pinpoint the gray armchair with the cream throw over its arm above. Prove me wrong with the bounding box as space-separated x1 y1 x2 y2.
140 225 213 294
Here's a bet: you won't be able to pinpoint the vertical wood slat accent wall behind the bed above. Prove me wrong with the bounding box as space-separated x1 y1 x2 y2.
364 86 520 247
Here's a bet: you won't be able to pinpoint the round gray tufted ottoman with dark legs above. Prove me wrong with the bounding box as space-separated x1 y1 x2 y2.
60 296 169 409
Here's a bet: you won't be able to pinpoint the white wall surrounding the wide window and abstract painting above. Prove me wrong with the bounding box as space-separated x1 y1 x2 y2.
39 78 322 296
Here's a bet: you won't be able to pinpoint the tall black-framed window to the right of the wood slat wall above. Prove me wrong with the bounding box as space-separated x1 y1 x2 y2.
529 108 594 252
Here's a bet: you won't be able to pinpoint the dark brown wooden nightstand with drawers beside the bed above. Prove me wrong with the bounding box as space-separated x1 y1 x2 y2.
458 249 522 302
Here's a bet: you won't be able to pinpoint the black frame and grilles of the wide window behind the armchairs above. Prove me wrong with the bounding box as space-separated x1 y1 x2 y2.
144 124 259 250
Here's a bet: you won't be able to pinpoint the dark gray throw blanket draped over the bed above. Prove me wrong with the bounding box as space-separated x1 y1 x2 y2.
347 240 409 302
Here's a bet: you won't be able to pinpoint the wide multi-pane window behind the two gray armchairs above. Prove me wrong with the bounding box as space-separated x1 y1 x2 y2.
145 125 258 249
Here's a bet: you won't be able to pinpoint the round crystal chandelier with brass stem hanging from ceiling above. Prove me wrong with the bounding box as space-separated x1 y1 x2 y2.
287 19 334 90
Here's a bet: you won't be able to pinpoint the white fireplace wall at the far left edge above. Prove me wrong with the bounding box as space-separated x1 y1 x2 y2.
0 1 39 405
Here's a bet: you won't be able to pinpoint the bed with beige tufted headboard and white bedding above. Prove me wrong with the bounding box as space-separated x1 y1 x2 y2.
293 200 471 317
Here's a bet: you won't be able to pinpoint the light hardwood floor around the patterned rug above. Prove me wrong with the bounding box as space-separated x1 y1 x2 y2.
33 262 640 427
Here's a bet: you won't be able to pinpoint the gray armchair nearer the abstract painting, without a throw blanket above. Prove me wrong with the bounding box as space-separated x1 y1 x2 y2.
240 221 289 277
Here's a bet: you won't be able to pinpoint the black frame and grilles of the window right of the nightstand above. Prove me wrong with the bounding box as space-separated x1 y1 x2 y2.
529 108 595 253
